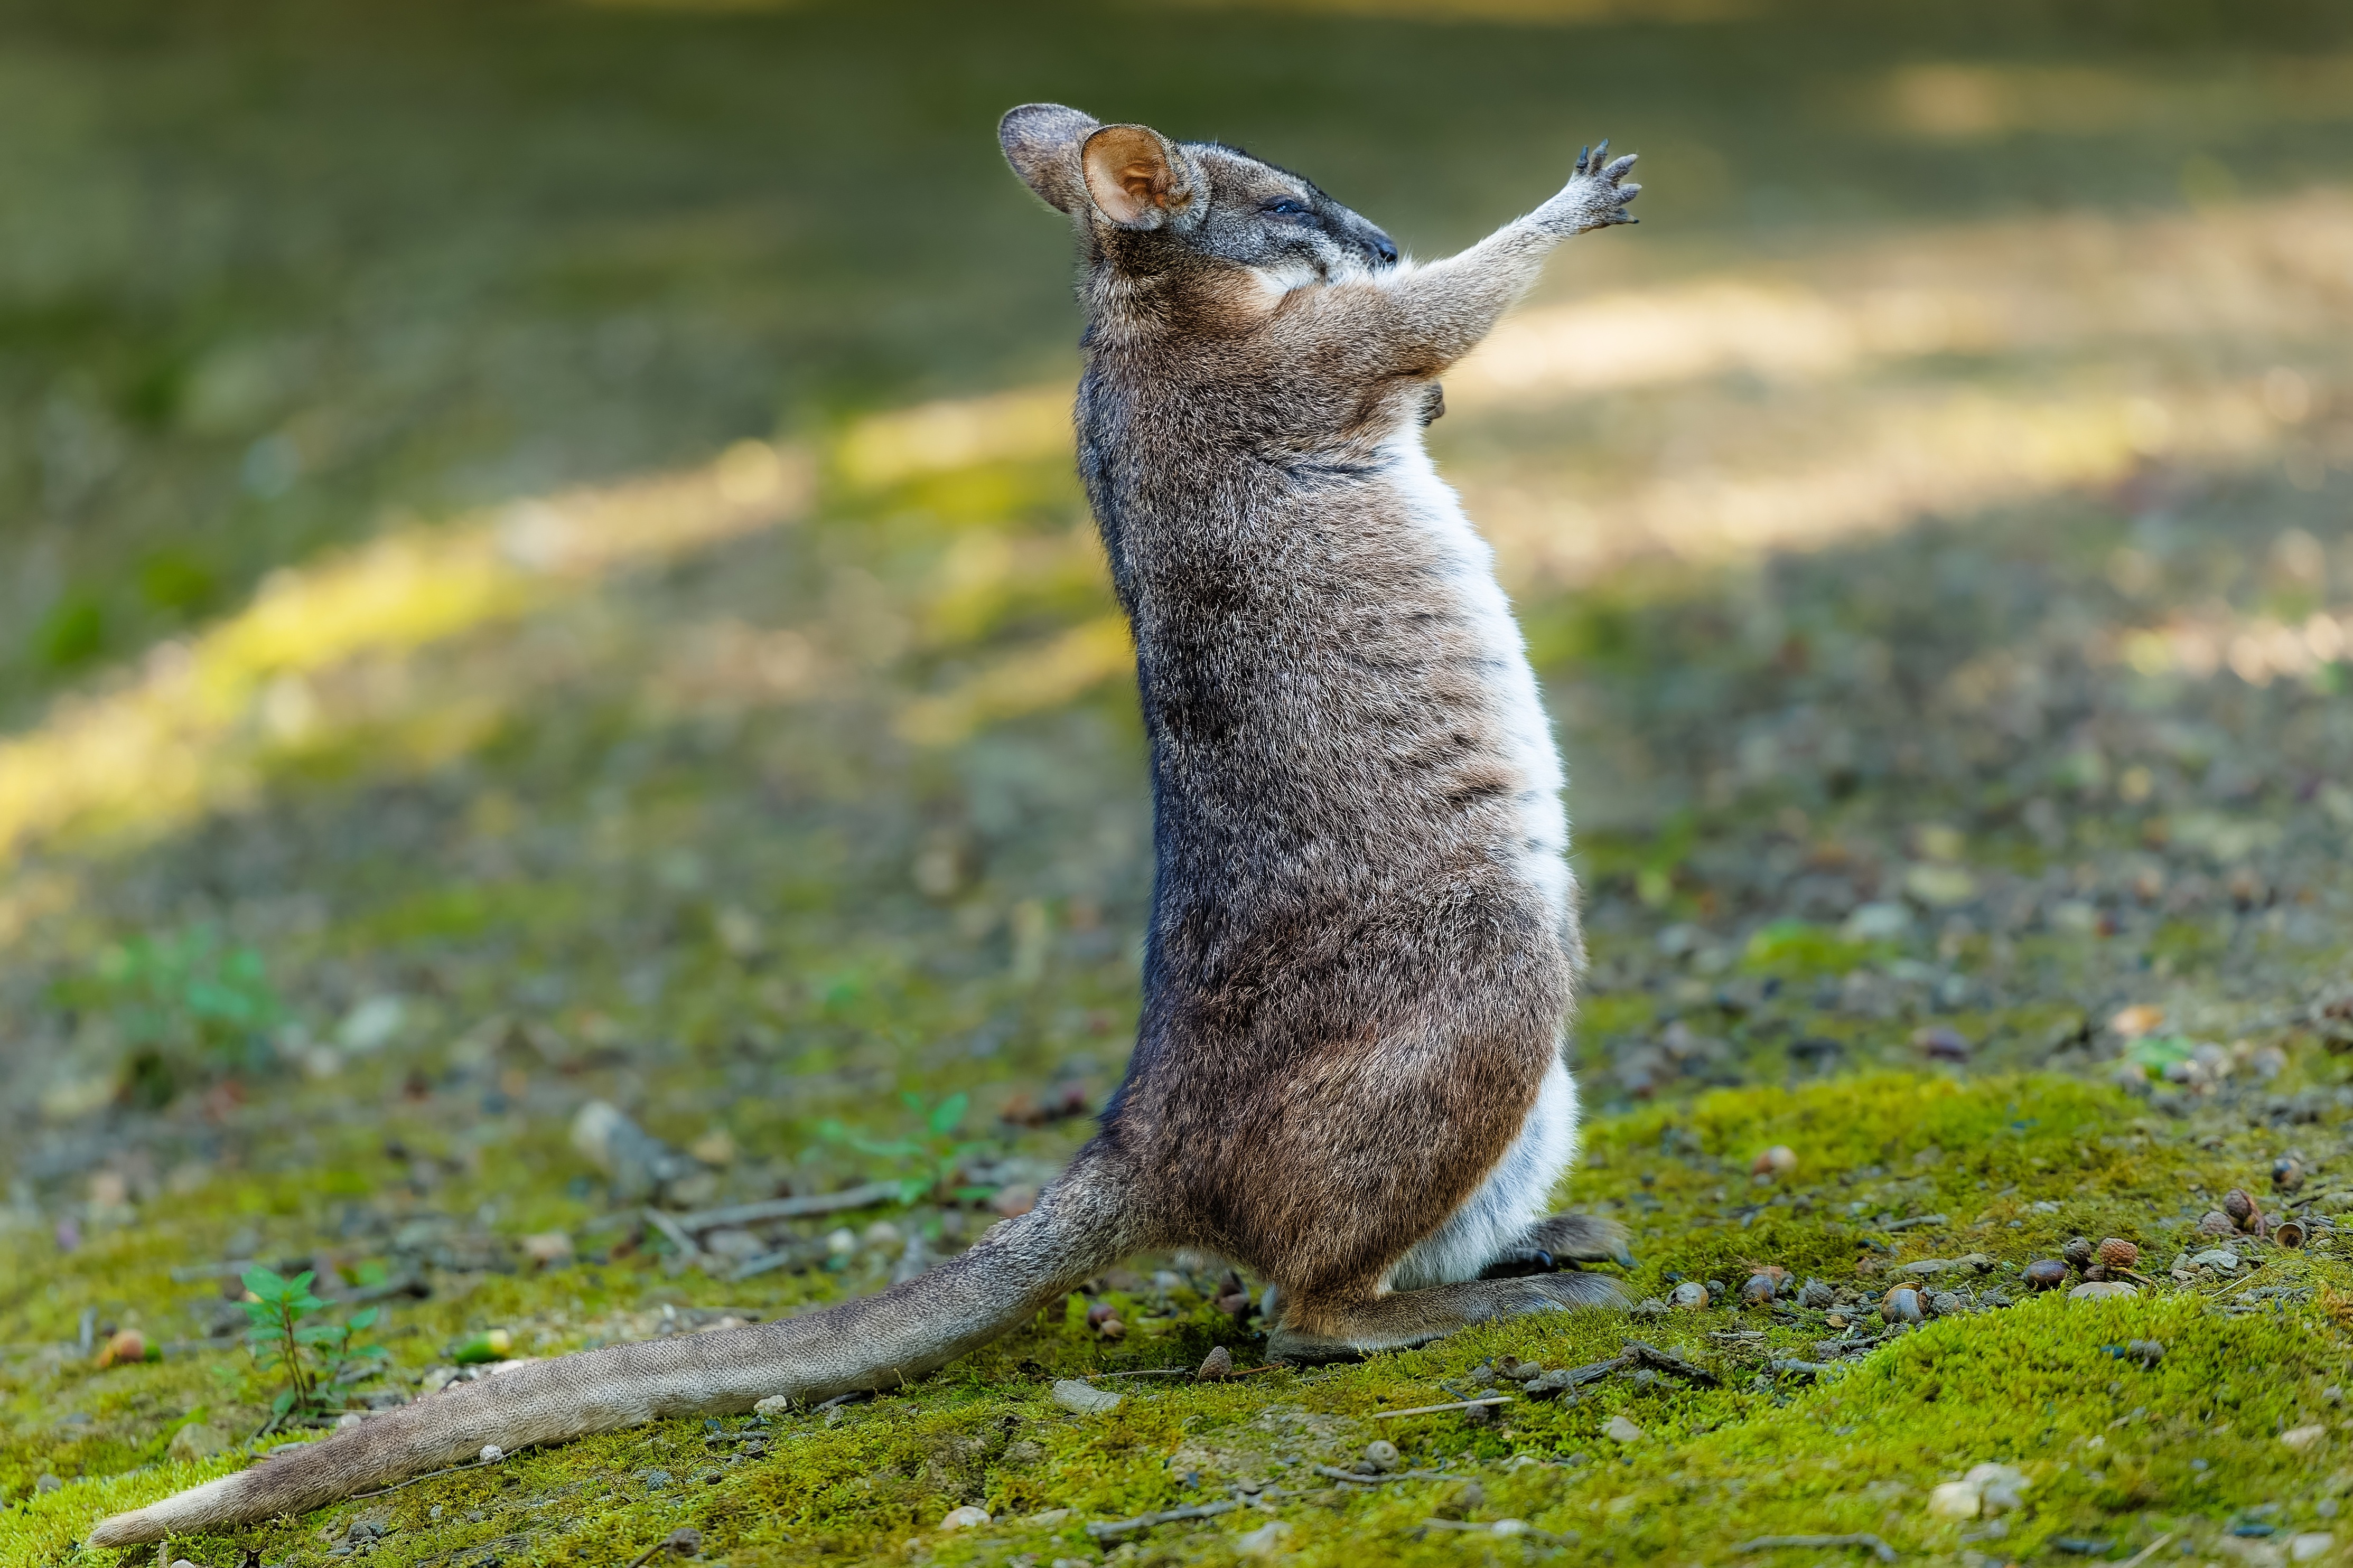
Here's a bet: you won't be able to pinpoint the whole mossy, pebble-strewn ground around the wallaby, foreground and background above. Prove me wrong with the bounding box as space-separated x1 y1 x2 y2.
0 0 2353 1568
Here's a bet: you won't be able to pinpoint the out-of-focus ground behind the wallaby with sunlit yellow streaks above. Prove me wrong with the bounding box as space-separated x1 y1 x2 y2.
0 0 2353 1288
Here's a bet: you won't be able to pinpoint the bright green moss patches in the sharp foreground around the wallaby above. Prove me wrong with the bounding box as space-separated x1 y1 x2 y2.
0 1074 2353 1568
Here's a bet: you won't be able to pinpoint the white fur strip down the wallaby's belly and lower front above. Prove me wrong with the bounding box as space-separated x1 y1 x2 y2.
1388 426 1576 1291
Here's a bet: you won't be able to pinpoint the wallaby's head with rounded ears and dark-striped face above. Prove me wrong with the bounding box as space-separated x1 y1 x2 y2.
997 104 1398 282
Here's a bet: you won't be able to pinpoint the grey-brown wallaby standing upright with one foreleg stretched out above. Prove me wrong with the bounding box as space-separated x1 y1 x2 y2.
89 104 1640 1547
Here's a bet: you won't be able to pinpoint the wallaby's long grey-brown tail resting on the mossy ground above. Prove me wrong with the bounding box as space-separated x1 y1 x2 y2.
89 1157 1134 1547
